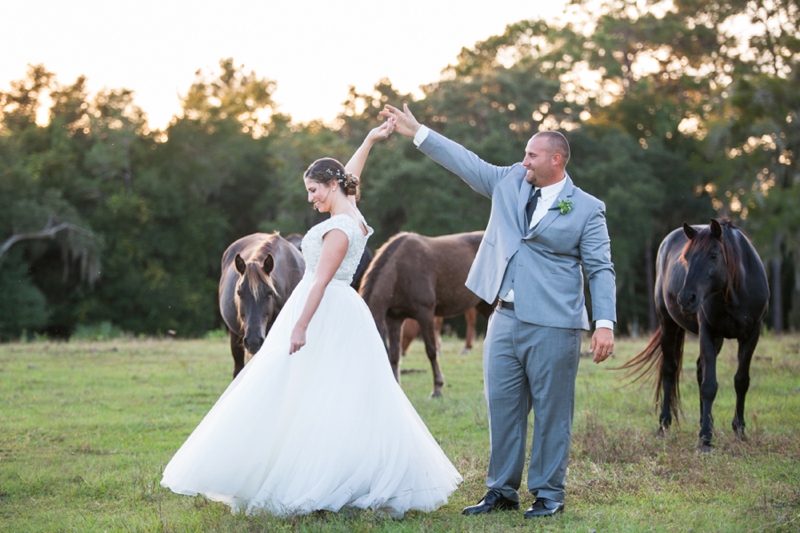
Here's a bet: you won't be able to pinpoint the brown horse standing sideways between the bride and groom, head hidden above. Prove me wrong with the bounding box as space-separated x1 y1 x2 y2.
361 231 491 397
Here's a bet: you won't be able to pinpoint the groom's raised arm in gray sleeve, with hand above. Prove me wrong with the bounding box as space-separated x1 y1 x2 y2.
380 104 511 198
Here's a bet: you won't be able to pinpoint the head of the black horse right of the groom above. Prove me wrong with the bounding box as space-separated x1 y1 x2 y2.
678 220 739 315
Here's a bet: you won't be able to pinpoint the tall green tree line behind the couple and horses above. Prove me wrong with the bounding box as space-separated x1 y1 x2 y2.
0 0 800 340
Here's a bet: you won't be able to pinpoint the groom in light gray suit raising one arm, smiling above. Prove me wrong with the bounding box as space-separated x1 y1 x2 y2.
381 105 616 518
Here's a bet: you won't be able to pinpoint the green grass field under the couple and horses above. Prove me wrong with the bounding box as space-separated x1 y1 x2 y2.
0 337 800 532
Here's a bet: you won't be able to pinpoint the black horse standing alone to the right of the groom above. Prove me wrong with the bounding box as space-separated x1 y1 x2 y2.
622 220 769 451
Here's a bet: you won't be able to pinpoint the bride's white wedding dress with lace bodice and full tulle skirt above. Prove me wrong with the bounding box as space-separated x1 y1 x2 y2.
161 215 462 517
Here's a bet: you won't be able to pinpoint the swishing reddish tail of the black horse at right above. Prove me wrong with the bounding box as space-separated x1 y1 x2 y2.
616 326 686 420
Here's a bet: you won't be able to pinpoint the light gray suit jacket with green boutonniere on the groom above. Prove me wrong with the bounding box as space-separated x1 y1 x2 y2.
419 130 617 329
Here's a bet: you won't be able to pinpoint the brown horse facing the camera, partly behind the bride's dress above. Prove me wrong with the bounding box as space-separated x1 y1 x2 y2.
219 232 305 378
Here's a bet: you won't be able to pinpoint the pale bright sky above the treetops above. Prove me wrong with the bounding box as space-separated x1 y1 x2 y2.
0 0 567 129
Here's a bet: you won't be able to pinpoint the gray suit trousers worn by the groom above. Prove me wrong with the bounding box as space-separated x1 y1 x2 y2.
483 308 583 502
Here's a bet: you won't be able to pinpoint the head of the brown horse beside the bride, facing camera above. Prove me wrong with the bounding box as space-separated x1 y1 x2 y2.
234 254 279 354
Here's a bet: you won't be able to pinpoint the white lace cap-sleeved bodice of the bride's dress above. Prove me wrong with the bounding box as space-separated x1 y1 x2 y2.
302 215 372 285
